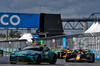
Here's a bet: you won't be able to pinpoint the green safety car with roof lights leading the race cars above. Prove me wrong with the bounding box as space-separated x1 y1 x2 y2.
9 45 57 64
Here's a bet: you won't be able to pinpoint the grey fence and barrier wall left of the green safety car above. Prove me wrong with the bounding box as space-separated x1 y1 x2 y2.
0 40 27 56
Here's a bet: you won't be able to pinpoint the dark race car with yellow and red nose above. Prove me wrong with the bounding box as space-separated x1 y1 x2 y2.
65 50 95 63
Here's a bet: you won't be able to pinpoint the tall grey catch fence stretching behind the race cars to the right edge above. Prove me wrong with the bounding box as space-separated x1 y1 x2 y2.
36 33 100 50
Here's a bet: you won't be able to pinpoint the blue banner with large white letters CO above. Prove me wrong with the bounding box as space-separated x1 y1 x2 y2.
0 12 40 28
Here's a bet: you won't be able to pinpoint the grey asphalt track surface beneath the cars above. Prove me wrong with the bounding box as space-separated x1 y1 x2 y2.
0 57 100 66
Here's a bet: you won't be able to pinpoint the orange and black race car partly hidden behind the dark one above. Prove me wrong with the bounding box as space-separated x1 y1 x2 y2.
57 48 72 59
